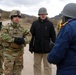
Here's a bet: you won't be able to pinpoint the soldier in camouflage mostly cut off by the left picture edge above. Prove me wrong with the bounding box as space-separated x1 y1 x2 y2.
0 9 3 75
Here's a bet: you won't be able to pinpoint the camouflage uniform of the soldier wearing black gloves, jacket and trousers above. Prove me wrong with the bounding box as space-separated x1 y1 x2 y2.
0 23 27 75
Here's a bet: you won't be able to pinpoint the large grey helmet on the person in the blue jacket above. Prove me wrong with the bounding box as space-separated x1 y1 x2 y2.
61 3 76 18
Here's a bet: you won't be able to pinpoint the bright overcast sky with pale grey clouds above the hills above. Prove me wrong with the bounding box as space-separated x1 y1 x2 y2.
0 0 76 17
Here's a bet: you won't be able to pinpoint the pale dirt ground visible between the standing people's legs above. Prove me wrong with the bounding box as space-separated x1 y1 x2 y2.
22 44 56 75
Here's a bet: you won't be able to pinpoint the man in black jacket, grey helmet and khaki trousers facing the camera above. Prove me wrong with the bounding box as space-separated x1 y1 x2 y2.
29 7 56 75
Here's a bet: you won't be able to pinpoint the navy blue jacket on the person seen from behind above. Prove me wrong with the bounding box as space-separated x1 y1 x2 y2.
47 20 76 75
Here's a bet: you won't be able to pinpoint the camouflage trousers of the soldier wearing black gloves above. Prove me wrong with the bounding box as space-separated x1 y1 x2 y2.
3 49 23 75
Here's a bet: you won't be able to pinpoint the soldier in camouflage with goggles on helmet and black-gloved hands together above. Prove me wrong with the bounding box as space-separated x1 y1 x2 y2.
0 10 28 75
